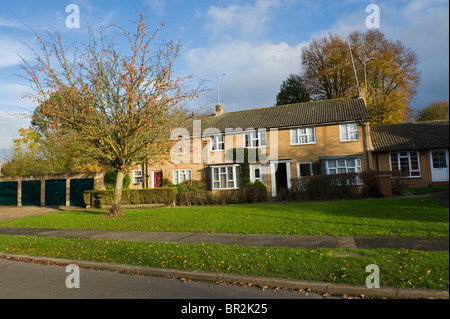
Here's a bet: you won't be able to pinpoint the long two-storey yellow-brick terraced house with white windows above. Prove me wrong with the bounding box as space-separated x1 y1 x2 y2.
132 97 374 196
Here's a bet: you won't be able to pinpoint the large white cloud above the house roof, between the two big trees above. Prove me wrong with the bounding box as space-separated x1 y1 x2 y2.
187 41 304 111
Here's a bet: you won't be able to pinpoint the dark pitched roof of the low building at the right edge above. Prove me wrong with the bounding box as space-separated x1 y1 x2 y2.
370 120 449 152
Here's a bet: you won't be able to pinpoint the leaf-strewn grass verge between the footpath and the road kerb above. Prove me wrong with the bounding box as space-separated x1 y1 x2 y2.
0 235 449 290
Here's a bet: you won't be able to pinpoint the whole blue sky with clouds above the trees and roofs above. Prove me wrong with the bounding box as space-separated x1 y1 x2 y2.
0 0 449 155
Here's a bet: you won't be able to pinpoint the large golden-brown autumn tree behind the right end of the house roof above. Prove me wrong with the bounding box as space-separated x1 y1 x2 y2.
302 30 420 124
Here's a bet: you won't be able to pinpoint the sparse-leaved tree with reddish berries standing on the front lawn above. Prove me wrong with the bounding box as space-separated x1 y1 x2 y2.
22 14 201 215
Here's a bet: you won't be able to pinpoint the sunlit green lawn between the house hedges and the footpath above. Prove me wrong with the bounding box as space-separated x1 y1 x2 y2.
0 198 449 237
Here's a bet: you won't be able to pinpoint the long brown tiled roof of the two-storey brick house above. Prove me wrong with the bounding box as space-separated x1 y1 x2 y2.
186 98 370 132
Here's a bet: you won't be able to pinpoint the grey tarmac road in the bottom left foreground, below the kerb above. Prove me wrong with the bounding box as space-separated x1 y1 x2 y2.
0 259 323 300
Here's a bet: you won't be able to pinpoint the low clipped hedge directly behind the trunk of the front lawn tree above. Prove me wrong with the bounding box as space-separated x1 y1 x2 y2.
83 187 178 208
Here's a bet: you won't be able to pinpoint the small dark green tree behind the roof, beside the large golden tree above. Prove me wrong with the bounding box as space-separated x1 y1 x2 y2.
276 74 311 105
